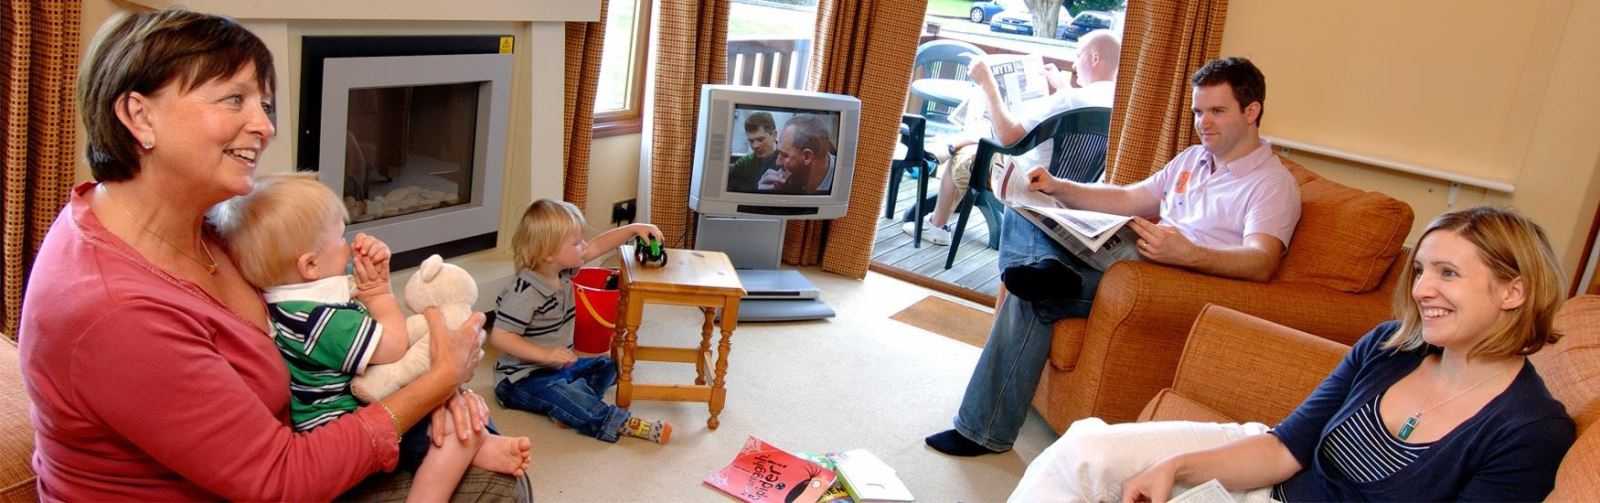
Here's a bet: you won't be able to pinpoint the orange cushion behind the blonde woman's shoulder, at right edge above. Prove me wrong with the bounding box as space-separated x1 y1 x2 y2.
1530 295 1600 434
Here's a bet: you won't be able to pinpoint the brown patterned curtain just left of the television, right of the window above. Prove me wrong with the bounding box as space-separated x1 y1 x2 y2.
646 0 728 248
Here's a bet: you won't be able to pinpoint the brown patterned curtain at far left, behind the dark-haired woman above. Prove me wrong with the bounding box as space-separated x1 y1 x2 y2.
0 0 82 340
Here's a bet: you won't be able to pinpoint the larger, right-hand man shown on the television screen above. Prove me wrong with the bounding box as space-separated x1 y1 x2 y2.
755 114 834 194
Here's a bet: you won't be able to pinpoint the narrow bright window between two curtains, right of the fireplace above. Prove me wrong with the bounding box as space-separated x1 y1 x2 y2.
594 0 651 138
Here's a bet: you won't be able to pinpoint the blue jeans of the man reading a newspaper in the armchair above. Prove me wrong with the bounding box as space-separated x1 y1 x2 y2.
955 208 1101 450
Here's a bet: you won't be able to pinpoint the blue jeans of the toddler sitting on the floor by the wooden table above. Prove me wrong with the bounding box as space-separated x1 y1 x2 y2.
494 356 629 442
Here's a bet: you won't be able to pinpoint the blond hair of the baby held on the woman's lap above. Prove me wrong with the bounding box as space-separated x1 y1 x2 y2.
210 173 349 288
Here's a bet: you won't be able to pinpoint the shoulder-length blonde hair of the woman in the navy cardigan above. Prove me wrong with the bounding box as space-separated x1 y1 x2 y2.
1382 207 1566 356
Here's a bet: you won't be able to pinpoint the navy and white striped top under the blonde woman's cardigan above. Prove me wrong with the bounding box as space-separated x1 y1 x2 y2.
1322 392 1434 484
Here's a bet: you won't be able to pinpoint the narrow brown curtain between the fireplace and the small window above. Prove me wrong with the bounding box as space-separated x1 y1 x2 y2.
562 0 611 208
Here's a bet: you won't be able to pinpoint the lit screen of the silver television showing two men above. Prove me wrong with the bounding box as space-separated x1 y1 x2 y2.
726 104 840 195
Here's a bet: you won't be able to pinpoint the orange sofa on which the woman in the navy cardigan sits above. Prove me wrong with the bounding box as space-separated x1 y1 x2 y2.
1139 295 1600 501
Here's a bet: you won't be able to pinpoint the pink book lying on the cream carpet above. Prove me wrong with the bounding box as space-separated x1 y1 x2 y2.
706 436 834 503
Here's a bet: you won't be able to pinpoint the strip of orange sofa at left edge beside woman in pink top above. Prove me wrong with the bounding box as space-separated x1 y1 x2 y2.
0 333 38 501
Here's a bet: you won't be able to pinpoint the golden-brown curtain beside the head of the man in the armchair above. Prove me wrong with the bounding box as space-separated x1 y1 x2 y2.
1106 0 1227 184
